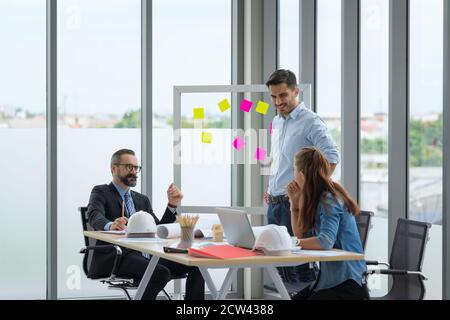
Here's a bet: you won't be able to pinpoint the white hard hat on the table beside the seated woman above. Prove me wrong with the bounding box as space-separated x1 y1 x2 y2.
253 224 292 256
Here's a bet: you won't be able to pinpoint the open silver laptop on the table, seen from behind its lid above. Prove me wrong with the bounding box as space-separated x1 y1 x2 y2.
217 208 255 249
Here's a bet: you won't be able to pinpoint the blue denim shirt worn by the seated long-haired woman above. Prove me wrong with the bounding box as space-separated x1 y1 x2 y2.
313 193 366 291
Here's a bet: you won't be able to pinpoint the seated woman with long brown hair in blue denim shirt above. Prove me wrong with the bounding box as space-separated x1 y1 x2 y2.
287 147 367 300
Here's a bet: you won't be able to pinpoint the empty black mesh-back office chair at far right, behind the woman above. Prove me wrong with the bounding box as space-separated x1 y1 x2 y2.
363 219 431 300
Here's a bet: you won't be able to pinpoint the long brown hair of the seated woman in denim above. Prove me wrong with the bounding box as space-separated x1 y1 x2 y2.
294 147 359 233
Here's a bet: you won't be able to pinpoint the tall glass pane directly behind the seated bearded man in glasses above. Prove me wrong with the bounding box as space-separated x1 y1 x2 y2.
57 0 141 298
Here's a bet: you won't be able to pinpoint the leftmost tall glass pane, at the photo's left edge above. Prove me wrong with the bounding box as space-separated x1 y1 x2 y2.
0 0 46 299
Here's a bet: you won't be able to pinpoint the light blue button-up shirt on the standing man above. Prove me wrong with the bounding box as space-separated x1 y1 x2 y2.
268 102 340 196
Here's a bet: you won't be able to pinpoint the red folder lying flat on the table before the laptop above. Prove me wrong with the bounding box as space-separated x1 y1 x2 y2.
188 244 259 259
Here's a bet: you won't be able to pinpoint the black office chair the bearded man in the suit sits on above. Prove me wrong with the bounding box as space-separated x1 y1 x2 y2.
78 207 187 300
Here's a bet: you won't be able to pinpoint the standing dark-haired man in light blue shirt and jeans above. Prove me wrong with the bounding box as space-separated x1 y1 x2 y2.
264 70 340 283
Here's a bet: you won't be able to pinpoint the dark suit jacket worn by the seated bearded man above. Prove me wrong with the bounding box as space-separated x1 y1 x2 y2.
87 183 176 278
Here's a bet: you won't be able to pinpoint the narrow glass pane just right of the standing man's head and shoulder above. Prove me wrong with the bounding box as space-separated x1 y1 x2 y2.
316 0 342 180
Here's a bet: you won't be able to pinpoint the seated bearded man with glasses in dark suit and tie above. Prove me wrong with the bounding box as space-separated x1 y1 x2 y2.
87 149 205 300
